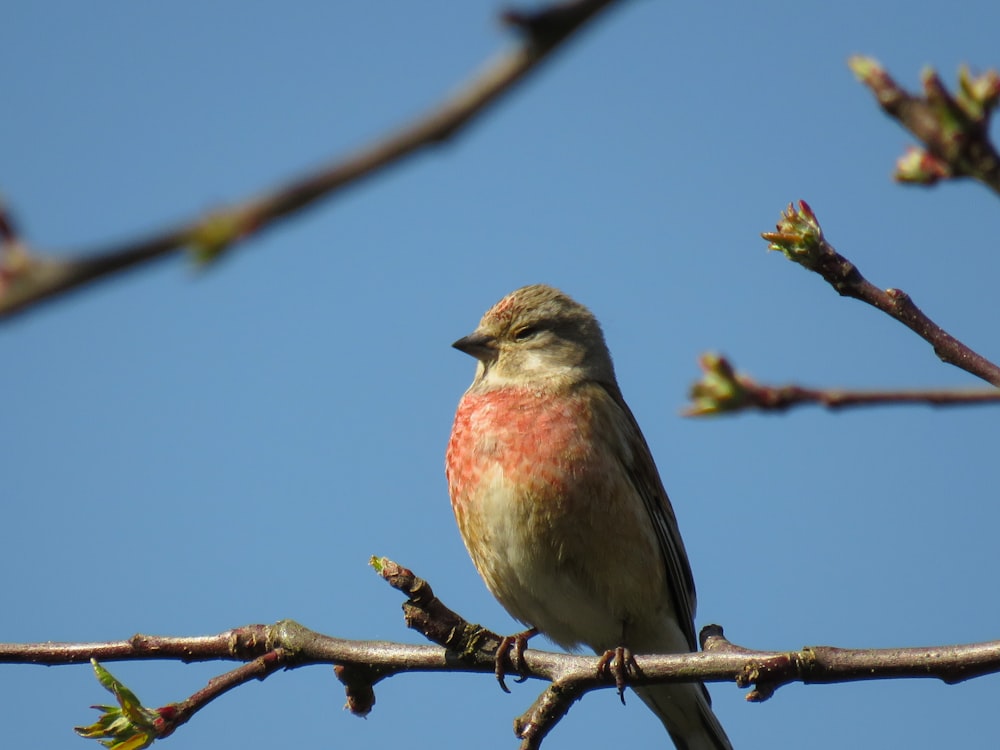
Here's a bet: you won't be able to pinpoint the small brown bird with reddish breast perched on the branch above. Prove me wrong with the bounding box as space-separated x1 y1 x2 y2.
446 284 732 750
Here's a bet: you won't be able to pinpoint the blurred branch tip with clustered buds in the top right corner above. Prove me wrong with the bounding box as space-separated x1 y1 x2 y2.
848 55 1000 194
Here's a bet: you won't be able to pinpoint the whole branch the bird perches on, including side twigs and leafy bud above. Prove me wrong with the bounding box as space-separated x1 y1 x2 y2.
0 558 1000 749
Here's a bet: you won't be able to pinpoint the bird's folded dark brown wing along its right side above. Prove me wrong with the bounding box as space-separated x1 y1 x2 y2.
602 383 698 651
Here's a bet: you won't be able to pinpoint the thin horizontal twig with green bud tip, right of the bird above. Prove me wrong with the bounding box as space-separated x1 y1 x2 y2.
684 354 1000 417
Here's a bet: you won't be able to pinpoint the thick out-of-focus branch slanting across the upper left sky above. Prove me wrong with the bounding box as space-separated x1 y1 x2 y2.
0 0 615 317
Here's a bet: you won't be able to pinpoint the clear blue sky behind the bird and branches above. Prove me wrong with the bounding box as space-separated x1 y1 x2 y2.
0 0 1000 750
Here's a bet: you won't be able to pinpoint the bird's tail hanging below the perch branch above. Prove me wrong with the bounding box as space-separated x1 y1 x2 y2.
635 682 733 750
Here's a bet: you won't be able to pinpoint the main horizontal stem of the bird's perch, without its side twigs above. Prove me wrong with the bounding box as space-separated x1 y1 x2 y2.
0 616 1000 690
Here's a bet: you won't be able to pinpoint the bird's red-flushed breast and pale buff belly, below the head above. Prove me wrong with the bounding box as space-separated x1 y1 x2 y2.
446 383 683 650
